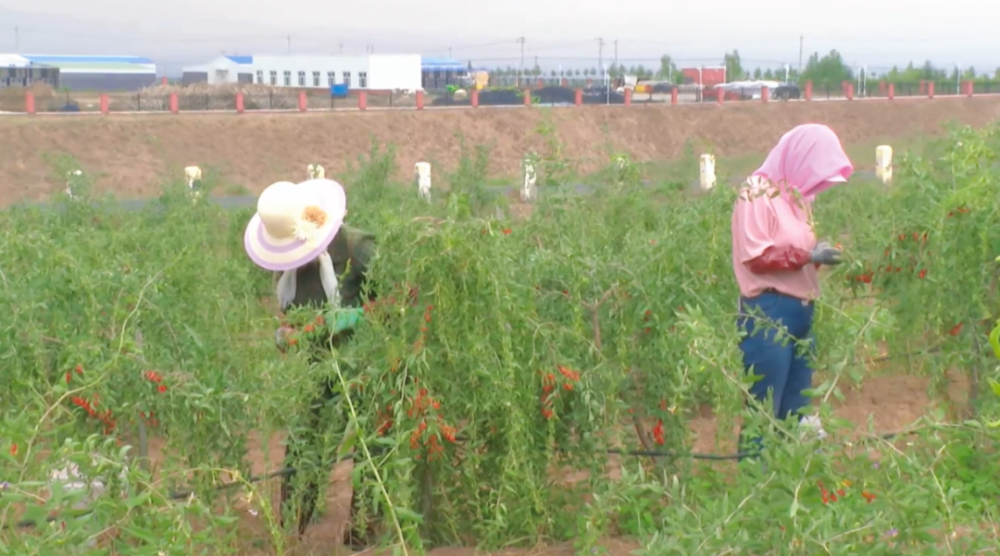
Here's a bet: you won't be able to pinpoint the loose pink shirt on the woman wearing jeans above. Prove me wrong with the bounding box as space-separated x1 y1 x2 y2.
733 176 819 300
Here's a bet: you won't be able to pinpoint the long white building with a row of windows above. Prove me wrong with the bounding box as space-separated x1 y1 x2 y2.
183 54 421 91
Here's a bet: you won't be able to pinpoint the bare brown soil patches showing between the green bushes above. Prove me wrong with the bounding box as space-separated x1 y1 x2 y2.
137 369 968 556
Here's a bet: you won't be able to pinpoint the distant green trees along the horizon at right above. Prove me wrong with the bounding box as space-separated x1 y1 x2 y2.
491 50 1000 87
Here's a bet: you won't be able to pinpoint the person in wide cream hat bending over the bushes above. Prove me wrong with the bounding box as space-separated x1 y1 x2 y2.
244 179 375 548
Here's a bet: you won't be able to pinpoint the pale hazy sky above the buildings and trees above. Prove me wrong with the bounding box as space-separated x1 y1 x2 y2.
0 0 1000 75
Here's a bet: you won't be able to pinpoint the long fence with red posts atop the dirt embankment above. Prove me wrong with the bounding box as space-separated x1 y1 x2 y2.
6 78 1000 114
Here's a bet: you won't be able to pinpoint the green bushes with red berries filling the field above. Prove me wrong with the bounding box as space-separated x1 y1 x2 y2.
0 128 1000 555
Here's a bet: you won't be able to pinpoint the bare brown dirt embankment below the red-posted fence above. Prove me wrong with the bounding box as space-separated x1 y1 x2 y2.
0 97 1000 205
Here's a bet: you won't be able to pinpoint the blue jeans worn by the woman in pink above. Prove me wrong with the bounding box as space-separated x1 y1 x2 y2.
738 293 815 456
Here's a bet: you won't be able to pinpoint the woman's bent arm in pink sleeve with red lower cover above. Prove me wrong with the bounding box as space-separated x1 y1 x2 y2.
733 190 812 274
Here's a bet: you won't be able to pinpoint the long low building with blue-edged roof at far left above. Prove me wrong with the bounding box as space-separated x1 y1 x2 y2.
0 54 156 91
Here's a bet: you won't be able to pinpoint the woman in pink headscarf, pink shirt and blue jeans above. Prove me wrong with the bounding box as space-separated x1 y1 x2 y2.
732 124 854 458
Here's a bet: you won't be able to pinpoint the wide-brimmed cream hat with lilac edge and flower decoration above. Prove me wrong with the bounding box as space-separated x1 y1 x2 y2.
243 179 347 271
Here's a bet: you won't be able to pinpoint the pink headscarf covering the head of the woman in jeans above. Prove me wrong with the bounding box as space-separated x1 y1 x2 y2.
753 124 854 202
